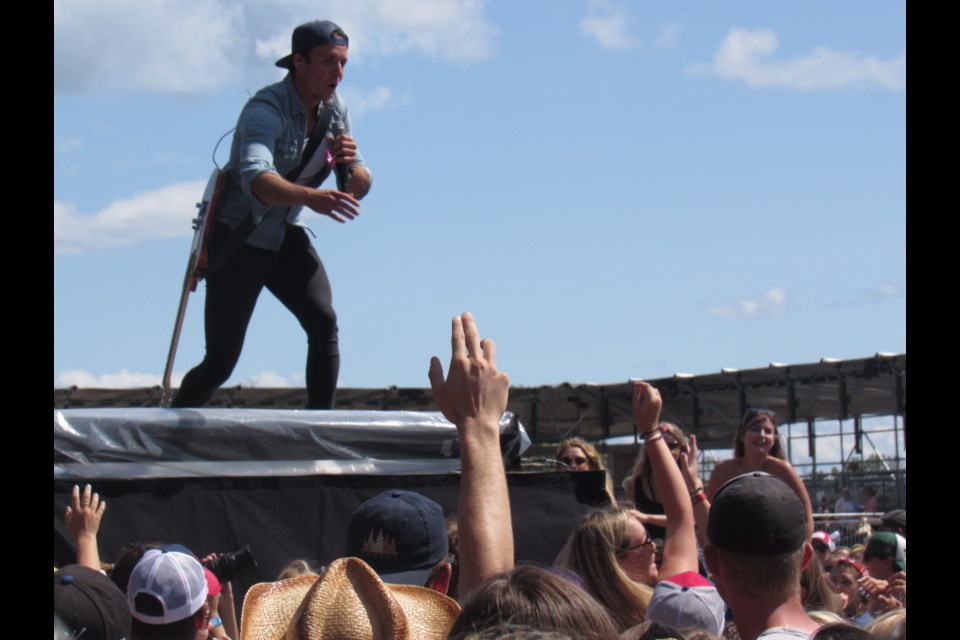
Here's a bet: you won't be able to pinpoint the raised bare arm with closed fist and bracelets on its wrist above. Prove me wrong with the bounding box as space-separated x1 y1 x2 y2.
633 382 698 578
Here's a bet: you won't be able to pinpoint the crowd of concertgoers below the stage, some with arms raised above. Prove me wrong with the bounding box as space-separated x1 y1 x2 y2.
54 313 906 640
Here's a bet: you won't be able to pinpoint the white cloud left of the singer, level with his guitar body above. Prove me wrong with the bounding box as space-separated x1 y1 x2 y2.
53 180 206 255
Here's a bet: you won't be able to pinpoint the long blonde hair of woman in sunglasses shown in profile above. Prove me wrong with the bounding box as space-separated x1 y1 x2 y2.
557 507 653 631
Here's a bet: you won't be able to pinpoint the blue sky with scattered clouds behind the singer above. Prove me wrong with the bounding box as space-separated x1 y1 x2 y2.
53 0 906 387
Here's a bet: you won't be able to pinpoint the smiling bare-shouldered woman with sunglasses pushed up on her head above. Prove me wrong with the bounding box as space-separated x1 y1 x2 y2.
707 409 813 539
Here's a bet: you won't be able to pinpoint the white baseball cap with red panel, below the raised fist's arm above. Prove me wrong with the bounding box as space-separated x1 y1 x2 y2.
646 571 726 638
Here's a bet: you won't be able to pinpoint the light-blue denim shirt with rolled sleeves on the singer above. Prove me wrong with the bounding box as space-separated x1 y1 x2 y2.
219 73 364 250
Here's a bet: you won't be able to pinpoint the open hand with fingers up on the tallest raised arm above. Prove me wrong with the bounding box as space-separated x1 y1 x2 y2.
429 313 510 428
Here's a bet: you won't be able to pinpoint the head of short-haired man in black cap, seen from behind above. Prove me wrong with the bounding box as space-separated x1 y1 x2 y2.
704 472 813 601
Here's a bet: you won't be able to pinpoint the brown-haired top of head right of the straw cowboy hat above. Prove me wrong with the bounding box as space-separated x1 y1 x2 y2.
447 565 618 640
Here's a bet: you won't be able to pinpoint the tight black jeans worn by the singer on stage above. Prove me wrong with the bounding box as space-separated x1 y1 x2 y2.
172 223 340 409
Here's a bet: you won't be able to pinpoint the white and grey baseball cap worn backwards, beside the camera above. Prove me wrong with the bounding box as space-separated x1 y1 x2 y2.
127 545 207 624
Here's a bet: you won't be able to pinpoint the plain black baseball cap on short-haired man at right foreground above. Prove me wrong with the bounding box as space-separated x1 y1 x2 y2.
707 471 807 556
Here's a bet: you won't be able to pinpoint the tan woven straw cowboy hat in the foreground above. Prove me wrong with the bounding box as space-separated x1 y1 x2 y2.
240 558 460 640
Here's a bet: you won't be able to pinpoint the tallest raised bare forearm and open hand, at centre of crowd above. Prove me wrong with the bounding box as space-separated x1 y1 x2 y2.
429 313 513 600
